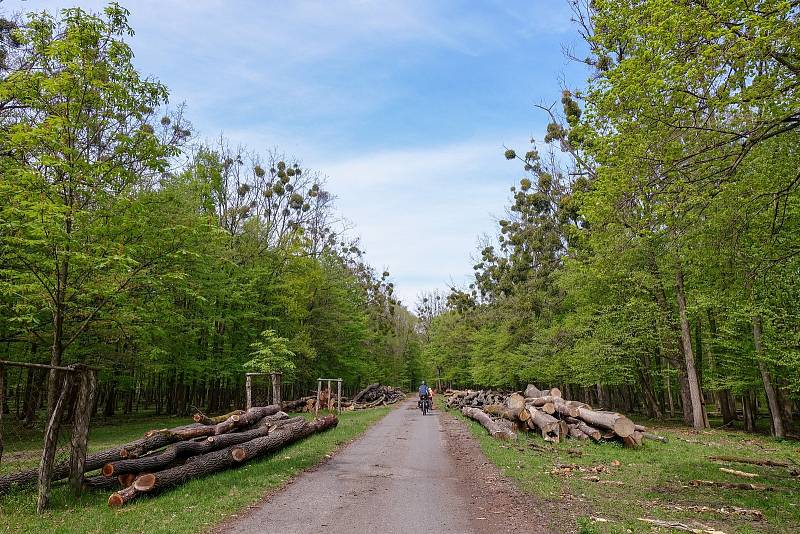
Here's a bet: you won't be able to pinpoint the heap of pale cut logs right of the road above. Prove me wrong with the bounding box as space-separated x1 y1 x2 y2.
445 384 664 448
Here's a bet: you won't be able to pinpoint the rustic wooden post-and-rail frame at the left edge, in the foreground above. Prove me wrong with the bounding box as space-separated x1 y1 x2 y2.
0 360 97 513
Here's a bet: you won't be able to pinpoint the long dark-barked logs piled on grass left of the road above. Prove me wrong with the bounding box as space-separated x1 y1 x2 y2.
0 401 338 506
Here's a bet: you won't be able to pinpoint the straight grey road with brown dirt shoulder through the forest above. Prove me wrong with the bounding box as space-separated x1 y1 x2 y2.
219 401 547 534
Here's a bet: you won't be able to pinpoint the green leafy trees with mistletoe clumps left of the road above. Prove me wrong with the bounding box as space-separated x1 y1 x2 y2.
0 3 421 426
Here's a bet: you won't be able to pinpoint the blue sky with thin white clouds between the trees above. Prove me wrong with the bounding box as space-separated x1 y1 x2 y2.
0 0 586 306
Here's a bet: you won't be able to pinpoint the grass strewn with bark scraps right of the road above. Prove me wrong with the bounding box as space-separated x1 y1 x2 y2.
449 410 800 534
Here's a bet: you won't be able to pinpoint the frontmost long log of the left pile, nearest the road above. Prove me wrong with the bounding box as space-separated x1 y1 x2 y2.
108 415 338 506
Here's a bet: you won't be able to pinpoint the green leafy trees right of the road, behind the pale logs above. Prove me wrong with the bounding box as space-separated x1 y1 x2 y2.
418 0 800 437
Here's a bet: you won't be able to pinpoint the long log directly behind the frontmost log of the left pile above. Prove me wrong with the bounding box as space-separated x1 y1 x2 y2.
102 416 305 477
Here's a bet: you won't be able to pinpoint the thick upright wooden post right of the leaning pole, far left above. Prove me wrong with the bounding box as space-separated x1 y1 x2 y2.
69 368 97 497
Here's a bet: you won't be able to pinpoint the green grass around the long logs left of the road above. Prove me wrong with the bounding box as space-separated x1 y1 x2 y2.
0 408 389 534
